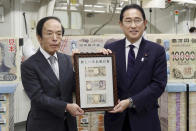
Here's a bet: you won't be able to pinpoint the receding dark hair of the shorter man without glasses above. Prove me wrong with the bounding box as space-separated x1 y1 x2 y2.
36 16 64 37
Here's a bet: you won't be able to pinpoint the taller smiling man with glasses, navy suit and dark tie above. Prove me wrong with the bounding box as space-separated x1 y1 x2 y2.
104 4 167 131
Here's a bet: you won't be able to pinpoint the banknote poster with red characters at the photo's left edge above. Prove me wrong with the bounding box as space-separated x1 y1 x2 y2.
0 38 19 83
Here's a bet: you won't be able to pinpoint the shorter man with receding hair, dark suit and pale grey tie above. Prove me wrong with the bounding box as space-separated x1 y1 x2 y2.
21 17 84 131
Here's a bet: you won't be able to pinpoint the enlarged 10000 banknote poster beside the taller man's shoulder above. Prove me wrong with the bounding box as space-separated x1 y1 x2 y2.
147 34 196 82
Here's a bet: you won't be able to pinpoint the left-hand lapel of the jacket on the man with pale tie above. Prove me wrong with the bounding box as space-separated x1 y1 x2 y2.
36 50 58 84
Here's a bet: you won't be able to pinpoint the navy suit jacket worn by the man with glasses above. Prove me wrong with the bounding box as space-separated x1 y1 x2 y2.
105 38 167 131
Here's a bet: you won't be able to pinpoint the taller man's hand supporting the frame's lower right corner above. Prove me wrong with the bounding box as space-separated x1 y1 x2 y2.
109 99 130 113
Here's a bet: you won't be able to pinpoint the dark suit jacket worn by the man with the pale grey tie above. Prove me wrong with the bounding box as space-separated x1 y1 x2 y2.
21 50 77 131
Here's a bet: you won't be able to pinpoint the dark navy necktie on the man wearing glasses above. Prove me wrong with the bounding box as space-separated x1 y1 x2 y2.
127 45 135 78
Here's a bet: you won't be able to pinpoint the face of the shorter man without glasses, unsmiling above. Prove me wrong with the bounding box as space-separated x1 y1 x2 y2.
37 19 62 55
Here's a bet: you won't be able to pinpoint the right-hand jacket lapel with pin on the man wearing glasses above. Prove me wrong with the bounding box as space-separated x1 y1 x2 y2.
128 38 148 85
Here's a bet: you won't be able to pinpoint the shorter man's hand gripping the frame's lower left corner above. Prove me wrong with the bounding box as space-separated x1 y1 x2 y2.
66 103 84 117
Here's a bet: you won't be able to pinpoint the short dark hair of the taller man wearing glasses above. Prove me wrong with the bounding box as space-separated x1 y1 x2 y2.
120 4 146 22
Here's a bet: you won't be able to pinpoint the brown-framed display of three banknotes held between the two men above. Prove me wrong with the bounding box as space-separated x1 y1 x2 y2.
74 53 118 111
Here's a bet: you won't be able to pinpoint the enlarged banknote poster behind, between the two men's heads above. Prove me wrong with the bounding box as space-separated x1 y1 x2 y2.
60 34 124 55
